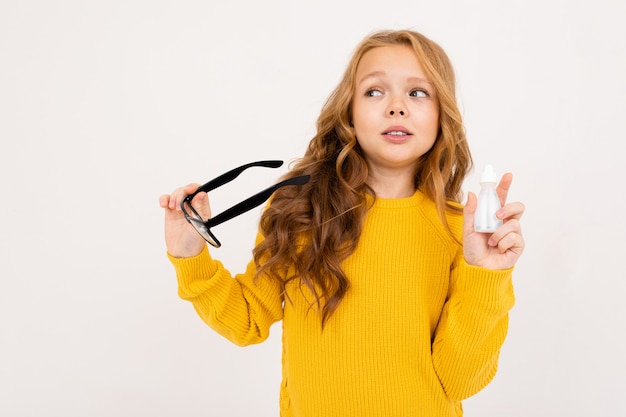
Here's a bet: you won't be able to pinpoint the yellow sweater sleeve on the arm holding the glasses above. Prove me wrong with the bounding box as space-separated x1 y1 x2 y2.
168 247 283 346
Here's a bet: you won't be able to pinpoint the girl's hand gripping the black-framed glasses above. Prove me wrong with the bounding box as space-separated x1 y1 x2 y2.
159 184 211 258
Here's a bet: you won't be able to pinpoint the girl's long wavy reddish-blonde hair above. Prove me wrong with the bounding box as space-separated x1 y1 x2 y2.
253 30 472 326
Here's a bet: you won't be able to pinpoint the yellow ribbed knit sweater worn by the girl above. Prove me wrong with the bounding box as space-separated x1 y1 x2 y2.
170 191 514 417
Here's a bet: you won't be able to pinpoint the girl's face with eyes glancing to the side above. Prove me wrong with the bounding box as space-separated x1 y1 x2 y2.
352 45 439 180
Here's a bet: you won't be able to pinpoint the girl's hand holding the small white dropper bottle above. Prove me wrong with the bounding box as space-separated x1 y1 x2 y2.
463 173 525 269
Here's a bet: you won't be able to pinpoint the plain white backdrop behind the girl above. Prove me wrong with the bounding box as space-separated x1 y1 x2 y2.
0 0 626 417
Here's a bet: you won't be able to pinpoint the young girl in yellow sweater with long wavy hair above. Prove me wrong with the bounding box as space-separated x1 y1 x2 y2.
160 31 524 417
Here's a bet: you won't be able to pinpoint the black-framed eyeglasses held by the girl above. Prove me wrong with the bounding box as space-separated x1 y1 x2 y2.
180 161 311 248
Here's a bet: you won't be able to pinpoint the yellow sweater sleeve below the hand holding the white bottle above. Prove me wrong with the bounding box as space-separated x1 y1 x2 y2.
432 256 515 401
